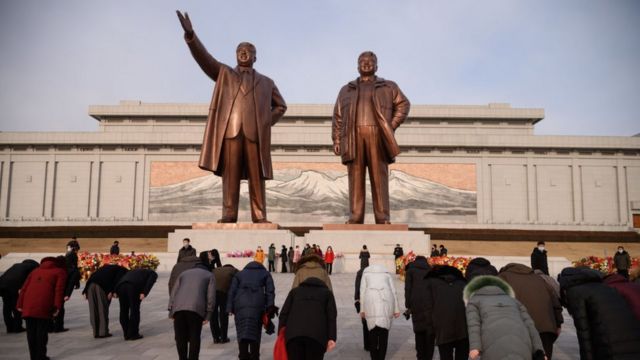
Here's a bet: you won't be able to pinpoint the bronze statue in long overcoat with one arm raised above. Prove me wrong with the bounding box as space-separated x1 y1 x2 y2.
176 11 287 223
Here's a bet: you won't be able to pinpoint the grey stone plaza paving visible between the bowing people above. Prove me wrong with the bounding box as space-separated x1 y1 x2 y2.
0 272 579 360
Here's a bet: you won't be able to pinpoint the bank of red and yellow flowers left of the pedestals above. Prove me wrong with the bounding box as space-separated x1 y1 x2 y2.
78 251 160 280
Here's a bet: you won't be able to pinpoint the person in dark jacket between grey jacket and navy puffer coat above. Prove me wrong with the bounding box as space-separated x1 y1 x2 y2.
209 264 238 344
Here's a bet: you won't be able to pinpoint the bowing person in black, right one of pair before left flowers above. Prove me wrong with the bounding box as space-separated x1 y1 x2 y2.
115 269 158 340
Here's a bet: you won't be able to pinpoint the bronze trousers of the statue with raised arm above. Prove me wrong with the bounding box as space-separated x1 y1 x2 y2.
221 131 267 222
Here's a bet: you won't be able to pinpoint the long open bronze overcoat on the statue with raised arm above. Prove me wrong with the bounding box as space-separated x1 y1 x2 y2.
187 34 287 179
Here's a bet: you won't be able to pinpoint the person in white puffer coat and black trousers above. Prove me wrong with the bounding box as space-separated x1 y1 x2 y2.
360 264 400 360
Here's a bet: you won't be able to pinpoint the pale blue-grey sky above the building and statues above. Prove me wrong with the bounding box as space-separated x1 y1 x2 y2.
0 0 640 136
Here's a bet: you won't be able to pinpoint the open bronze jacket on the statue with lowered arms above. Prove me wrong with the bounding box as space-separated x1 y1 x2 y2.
331 77 411 164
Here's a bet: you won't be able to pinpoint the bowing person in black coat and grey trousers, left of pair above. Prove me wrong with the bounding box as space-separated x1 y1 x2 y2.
82 265 128 339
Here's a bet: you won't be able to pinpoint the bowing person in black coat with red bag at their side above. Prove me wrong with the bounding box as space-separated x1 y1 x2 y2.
278 277 338 359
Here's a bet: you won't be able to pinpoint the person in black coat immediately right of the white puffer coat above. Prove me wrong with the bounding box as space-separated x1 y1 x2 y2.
404 256 435 360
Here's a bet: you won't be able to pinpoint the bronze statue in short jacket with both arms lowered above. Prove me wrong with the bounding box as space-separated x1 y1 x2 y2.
331 51 411 224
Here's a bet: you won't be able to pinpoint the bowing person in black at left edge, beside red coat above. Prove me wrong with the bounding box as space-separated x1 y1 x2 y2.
0 259 39 333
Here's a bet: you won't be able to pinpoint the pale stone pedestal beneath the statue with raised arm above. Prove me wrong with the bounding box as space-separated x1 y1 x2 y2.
167 228 295 256
